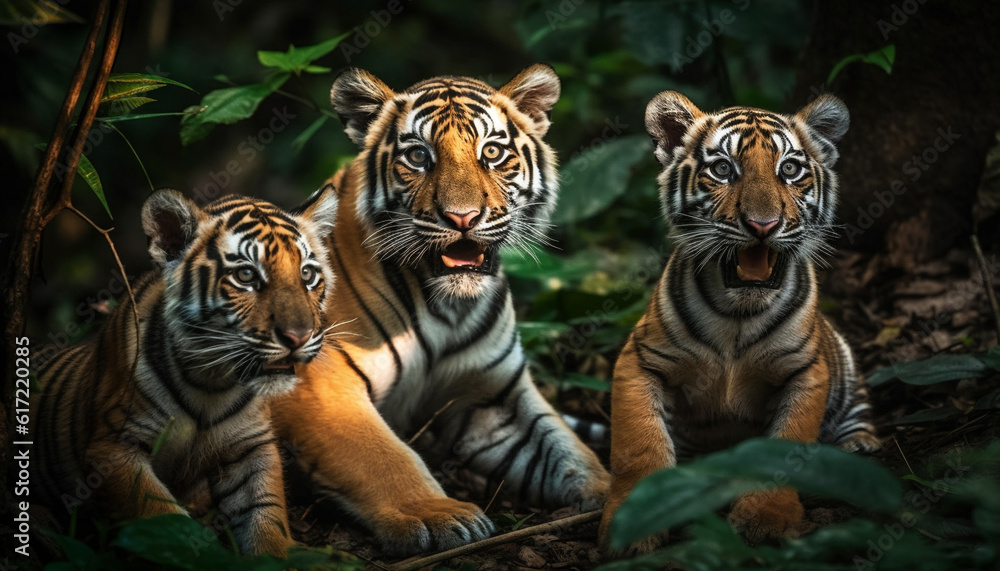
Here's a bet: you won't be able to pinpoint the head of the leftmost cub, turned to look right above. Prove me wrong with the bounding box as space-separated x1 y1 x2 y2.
142 186 337 395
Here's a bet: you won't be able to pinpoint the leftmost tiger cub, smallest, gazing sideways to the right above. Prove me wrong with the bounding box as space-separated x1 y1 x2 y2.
32 187 337 557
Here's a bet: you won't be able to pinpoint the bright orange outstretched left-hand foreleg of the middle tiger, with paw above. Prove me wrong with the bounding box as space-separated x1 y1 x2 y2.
271 354 494 554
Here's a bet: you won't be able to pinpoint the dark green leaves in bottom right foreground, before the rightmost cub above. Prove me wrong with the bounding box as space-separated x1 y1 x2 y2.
600 440 1000 571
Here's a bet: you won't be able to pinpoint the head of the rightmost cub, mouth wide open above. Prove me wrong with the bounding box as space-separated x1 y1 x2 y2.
646 91 849 298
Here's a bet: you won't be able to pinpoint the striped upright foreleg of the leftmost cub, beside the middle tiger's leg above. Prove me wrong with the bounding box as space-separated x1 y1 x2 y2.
209 431 293 559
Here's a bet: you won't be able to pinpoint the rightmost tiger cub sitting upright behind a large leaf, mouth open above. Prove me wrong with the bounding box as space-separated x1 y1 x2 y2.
601 91 879 550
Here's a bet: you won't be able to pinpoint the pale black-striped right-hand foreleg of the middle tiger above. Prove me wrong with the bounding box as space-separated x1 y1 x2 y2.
452 367 610 511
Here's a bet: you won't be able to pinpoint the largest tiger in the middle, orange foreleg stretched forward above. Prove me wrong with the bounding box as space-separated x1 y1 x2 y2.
273 65 610 552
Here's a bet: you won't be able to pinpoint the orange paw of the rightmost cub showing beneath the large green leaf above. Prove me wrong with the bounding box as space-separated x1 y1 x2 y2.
729 488 804 543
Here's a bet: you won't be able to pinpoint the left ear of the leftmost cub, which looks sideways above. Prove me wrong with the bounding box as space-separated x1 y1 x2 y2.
142 188 206 268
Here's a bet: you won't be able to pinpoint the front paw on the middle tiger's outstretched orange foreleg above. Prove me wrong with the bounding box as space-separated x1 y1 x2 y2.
372 497 496 555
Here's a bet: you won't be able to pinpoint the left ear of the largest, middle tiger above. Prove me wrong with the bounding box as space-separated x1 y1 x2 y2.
330 67 396 147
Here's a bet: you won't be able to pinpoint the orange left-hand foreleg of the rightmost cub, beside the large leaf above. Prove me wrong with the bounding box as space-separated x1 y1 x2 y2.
599 339 677 557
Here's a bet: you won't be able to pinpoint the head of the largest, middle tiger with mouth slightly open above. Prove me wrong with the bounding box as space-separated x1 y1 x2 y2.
331 65 560 297
